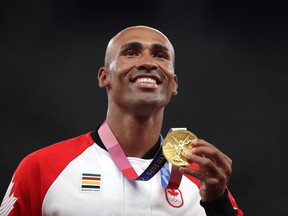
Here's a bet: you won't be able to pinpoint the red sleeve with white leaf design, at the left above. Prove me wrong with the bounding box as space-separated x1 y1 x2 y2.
0 133 94 216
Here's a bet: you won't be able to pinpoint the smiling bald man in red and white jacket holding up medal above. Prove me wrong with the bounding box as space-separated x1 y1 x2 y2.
0 26 243 216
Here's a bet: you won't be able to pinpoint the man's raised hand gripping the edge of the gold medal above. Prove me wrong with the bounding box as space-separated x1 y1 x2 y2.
180 139 232 202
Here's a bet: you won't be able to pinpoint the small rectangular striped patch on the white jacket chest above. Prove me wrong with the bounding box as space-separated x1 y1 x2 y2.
80 173 101 192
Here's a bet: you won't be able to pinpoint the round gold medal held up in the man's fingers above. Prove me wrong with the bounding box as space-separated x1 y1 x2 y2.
162 130 197 166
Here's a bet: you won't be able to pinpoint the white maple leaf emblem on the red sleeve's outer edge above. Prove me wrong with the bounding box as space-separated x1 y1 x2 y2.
0 179 18 216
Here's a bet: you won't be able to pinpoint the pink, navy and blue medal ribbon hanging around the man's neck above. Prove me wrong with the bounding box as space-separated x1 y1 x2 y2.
98 120 182 189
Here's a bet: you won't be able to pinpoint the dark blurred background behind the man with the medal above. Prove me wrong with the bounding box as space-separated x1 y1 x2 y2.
0 0 288 216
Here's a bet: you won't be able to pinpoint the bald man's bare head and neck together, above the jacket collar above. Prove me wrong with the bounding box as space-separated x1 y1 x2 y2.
98 27 178 157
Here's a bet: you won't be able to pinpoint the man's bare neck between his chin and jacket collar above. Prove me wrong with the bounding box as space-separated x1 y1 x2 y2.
107 113 163 158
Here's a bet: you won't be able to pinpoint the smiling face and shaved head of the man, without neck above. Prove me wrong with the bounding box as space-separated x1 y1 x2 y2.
100 27 178 115
